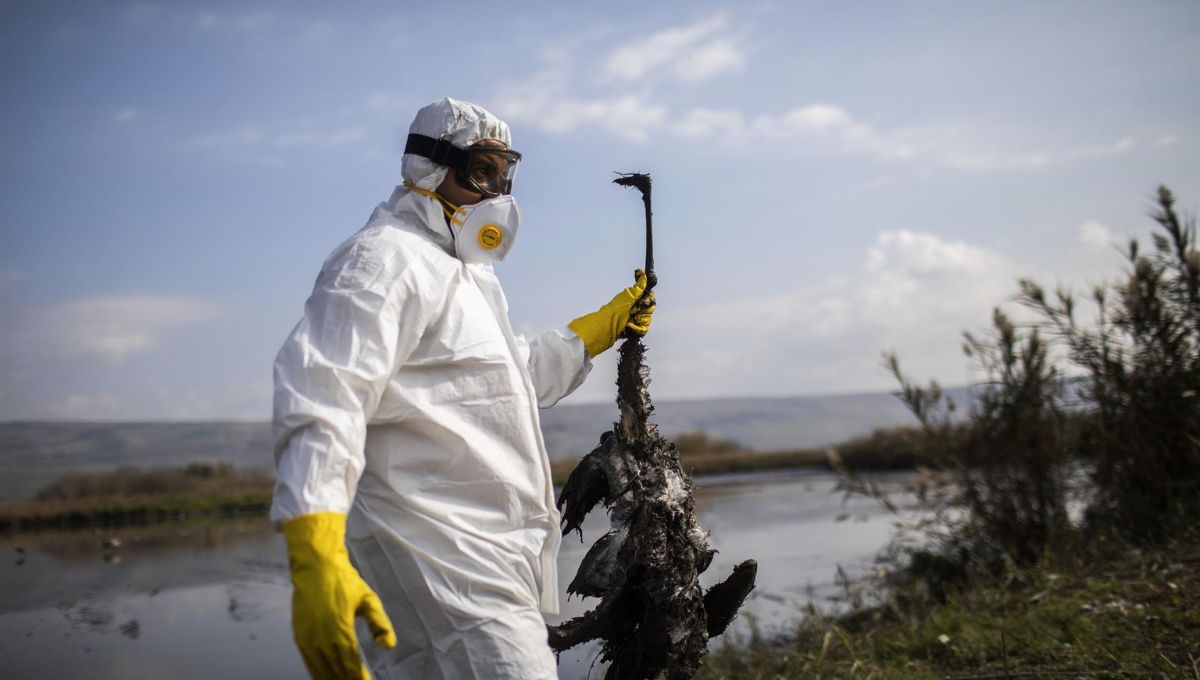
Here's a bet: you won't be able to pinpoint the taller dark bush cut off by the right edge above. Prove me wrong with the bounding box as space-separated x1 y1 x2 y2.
1020 187 1200 542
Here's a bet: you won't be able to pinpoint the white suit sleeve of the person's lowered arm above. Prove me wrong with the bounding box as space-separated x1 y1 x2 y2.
271 248 425 524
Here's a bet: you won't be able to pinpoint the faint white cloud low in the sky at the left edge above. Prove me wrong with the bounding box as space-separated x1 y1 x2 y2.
4 295 221 365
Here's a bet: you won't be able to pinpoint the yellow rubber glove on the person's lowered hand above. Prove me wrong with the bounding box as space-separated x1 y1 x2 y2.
283 512 396 680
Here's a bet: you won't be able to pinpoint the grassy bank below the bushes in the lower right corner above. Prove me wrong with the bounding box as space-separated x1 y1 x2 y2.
697 543 1200 680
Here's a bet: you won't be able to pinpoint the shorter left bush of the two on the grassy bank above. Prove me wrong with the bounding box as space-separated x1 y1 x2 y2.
878 309 1075 571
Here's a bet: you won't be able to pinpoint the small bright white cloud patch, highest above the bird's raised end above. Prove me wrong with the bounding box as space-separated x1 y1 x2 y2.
601 14 745 83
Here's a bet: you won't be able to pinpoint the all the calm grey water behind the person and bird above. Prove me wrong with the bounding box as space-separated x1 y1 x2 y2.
0 471 899 680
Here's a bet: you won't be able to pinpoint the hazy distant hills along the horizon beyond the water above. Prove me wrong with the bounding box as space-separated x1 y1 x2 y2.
0 389 966 501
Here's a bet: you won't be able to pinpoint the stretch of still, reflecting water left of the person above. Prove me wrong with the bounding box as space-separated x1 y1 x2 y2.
0 518 304 679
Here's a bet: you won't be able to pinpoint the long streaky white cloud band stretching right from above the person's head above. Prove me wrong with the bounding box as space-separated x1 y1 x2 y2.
492 14 1138 171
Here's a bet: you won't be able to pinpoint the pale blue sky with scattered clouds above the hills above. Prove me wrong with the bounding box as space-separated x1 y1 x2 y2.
0 0 1200 420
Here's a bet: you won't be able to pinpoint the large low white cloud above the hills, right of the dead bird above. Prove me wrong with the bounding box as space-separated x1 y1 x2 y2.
654 230 1027 398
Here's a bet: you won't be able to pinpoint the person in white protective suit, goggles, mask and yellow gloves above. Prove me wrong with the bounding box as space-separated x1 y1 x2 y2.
271 98 654 680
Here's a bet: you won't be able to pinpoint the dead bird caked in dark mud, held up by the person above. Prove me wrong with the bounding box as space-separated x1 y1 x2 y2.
548 174 757 680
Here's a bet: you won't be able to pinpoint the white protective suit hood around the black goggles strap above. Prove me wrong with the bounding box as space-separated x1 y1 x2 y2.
388 97 512 255
